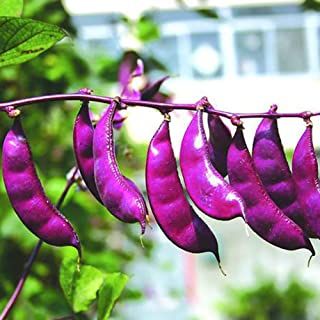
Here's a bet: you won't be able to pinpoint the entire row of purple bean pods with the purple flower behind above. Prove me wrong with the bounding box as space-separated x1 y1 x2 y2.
2 59 320 270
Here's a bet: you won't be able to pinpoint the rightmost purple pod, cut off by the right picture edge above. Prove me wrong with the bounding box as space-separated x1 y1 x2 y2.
292 120 320 238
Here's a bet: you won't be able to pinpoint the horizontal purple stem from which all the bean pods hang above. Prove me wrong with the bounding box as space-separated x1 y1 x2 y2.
0 93 320 119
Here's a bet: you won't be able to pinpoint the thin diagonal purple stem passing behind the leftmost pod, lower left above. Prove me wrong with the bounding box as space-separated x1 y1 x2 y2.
0 167 78 320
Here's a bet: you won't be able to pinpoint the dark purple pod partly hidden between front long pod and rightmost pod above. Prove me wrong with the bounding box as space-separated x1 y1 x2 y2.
252 105 310 235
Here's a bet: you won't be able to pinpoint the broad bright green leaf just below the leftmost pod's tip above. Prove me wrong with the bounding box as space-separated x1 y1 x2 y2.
59 251 105 312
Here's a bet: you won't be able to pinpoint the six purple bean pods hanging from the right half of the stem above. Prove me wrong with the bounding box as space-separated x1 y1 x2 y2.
146 98 320 270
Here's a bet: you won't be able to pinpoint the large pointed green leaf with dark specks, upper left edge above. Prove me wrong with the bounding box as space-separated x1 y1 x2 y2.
0 17 67 67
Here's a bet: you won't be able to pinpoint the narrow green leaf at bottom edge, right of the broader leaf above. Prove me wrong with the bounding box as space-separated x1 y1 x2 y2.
98 273 129 320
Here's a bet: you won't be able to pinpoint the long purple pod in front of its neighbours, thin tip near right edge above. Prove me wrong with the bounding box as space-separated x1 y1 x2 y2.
227 126 315 256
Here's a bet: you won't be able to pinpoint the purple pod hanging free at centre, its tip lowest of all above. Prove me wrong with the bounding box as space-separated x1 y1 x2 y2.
146 118 220 266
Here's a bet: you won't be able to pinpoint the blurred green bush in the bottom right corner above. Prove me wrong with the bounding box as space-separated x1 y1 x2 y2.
218 278 315 320
